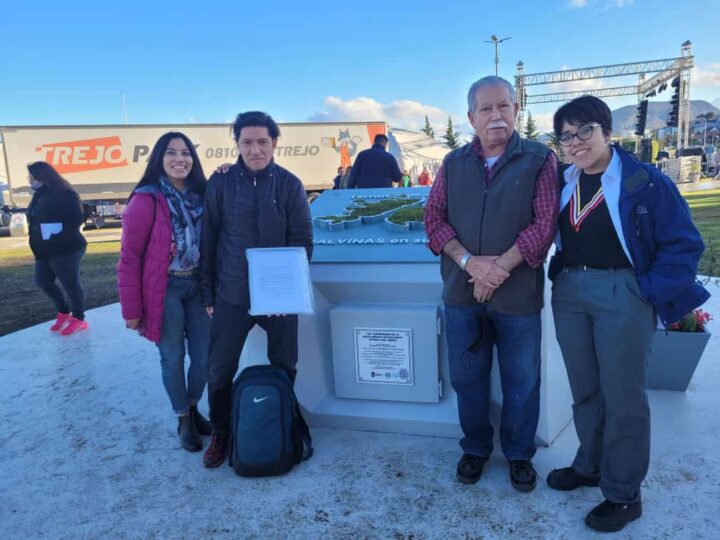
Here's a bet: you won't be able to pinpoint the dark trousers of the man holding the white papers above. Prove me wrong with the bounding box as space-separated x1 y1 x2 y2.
208 298 298 435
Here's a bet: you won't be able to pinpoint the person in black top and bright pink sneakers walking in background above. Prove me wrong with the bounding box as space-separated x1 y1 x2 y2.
27 161 88 336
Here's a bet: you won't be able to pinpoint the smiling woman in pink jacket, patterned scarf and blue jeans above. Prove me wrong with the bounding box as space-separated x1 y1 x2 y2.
117 132 211 452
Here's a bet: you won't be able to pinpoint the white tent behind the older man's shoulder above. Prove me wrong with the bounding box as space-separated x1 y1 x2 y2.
388 128 450 182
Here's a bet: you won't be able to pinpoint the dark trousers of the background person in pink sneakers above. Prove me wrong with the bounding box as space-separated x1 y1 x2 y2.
35 247 85 320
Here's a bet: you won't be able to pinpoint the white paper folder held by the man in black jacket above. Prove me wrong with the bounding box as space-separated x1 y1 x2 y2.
245 247 315 316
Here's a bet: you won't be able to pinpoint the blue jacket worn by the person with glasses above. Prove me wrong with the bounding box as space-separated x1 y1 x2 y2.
549 146 710 326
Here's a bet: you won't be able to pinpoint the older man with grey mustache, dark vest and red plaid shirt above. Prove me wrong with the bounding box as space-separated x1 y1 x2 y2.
425 76 558 492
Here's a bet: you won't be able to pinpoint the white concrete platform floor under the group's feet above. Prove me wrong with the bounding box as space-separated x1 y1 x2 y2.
0 286 720 539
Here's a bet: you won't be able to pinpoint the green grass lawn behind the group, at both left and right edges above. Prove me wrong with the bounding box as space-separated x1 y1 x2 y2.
0 189 720 336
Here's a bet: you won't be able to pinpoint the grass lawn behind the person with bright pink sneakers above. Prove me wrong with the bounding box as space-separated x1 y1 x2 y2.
0 242 120 336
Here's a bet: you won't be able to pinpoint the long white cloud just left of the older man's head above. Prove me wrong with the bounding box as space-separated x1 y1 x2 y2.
309 96 462 134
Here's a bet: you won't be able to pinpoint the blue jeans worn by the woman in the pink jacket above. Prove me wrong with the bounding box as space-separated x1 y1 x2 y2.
158 276 210 414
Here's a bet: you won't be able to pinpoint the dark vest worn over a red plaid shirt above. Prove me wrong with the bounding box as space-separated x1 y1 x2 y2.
440 132 550 314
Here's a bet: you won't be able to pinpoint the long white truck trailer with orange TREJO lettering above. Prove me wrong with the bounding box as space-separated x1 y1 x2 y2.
0 122 387 217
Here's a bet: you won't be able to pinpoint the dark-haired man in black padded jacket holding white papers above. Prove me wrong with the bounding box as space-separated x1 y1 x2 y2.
200 111 312 467
